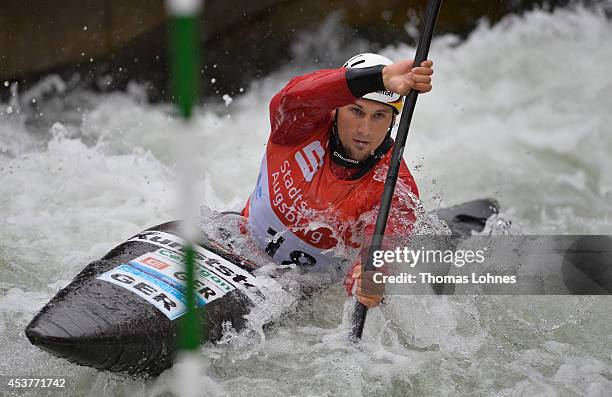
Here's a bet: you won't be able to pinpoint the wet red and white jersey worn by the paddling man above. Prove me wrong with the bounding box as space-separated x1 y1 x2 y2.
242 69 418 270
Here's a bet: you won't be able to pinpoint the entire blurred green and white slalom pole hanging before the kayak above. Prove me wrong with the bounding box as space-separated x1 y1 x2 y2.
166 0 202 351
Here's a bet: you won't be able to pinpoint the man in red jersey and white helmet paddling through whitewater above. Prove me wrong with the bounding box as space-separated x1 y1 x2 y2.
242 53 433 307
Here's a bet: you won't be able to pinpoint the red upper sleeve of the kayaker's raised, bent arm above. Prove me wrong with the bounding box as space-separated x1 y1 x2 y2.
270 68 355 145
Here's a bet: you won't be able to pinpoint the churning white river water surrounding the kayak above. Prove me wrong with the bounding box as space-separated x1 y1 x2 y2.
0 3 612 396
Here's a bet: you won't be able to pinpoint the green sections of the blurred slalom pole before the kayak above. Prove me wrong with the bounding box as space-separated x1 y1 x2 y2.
167 0 202 351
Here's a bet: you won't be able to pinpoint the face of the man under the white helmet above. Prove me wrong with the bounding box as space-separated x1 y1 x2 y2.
337 99 393 160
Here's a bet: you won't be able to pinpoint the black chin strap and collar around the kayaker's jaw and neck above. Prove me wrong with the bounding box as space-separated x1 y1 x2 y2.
329 109 395 179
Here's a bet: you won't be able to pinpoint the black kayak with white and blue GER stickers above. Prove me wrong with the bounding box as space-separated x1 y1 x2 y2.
25 199 498 376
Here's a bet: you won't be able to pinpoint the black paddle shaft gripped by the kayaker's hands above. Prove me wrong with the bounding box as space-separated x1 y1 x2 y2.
351 0 442 340
